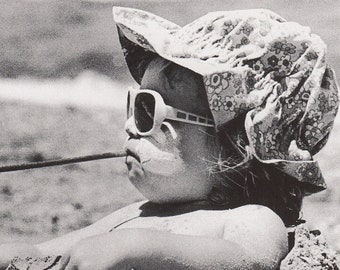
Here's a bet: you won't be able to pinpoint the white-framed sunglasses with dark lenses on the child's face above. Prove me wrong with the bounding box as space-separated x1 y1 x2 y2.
127 88 214 136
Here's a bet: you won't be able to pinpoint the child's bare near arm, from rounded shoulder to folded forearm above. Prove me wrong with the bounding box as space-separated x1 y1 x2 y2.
66 206 288 270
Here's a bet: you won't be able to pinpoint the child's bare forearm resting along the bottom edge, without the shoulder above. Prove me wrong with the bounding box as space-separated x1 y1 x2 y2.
66 229 253 270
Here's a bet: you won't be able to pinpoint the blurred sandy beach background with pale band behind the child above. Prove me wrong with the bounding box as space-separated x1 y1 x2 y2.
0 0 340 251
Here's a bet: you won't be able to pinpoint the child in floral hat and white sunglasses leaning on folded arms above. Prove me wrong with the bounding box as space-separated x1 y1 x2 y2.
0 8 338 269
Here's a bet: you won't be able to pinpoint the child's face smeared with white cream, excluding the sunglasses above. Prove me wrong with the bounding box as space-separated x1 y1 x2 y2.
125 58 219 202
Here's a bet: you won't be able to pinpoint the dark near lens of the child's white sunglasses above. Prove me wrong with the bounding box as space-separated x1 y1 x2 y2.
135 93 156 132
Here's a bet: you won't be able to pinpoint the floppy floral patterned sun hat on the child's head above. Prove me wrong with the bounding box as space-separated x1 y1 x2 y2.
113 7 338 193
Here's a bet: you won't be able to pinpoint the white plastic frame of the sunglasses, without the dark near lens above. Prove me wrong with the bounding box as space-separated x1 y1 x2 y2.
127 88 215 136
